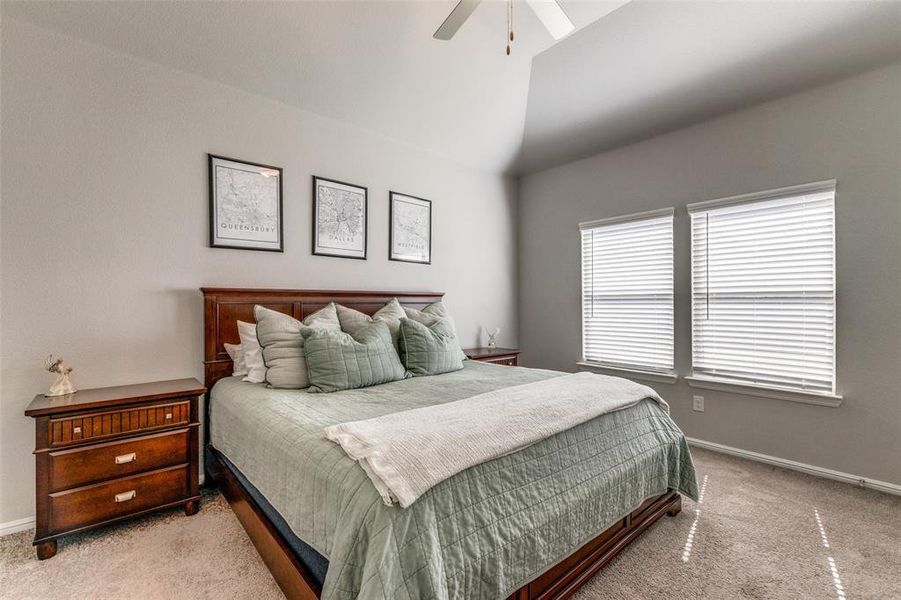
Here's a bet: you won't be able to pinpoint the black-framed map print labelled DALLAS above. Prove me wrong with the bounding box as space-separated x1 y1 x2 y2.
313 176 369 260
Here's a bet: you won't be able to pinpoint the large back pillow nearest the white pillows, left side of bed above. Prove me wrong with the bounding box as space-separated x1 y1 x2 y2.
253 303 341 389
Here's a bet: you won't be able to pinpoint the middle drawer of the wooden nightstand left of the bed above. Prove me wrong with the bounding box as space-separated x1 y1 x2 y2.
50 428 190 491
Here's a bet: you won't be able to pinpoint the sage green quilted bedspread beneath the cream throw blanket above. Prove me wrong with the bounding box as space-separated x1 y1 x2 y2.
211 361 697 600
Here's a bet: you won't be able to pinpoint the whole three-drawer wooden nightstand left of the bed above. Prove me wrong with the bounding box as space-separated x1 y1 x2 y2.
25 379 206 559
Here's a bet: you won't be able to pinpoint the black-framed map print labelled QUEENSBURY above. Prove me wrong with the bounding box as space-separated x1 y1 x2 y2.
209 154 284 252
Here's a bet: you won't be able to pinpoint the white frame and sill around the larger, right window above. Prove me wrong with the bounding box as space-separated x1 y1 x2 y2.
684 179 843 407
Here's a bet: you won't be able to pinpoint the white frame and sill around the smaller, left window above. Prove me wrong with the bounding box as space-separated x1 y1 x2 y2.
576 207 679 383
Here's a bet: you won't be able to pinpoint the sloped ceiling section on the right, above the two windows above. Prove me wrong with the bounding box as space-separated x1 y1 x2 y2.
516 1 901 172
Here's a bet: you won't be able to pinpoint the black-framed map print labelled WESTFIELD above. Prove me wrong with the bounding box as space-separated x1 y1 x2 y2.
388 192 432 265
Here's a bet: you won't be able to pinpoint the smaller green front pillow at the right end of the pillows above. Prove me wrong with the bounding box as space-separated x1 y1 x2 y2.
398 318 463 377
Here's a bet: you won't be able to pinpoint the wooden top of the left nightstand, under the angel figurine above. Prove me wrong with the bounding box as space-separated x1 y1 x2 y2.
25 377 206 417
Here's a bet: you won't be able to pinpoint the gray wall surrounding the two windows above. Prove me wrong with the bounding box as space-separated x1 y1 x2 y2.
519 65 901 484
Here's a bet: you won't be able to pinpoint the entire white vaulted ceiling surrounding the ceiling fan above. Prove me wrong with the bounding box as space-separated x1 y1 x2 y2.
0 0 901 172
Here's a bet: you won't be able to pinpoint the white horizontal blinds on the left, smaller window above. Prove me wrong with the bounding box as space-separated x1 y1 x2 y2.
579 208 673 372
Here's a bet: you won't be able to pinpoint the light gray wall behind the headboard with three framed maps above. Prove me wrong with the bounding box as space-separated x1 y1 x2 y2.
0 18 517 523
